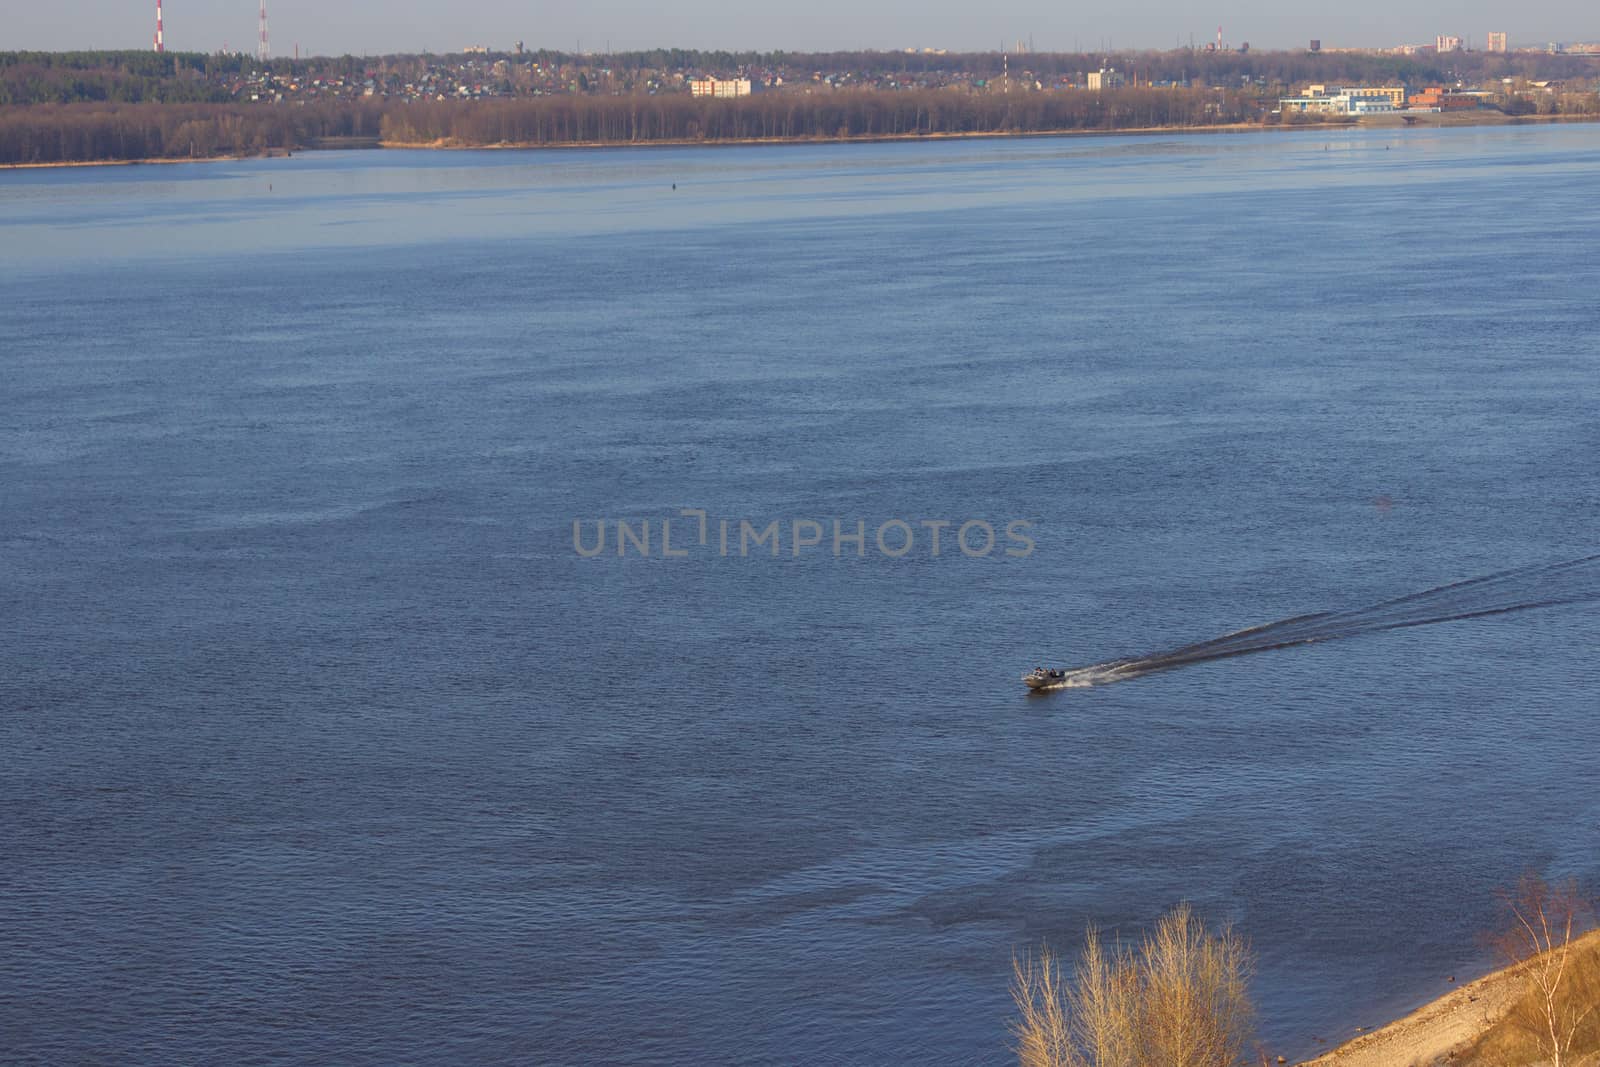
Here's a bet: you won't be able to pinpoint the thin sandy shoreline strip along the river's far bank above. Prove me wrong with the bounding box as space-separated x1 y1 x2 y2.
0 110 1600 171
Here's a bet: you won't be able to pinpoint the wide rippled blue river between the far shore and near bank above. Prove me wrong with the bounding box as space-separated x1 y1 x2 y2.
0 125 1600 1065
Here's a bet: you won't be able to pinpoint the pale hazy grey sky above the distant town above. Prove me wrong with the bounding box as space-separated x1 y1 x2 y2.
12 0 1600 56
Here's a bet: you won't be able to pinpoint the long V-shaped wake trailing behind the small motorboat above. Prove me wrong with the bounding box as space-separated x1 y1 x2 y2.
1035 555 1600 691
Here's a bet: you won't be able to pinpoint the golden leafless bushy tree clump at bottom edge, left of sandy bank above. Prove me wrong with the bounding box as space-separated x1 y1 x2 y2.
1011 904 1253 1067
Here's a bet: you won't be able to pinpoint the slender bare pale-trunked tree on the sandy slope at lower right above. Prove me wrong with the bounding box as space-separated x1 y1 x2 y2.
1496 875 1600 1067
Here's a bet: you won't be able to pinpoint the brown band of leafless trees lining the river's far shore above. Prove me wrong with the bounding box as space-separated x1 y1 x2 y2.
0 88 1262 163
